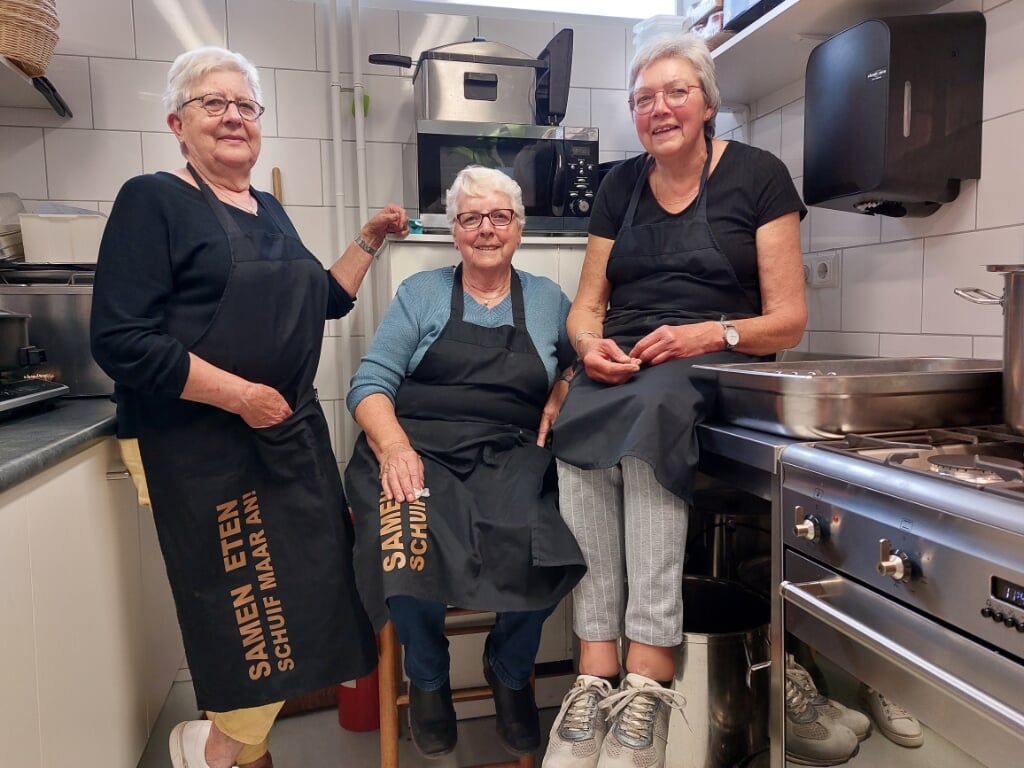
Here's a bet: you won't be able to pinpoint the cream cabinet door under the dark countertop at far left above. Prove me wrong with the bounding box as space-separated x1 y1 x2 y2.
23 439 148 768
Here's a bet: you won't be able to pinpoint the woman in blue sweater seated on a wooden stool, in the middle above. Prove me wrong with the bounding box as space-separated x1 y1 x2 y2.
345 166 583 758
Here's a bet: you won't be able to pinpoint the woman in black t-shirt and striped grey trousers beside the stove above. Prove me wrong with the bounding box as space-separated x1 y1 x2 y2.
544 35 806 768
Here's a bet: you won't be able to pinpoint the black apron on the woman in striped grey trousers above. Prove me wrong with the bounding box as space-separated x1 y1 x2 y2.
552 139 760 502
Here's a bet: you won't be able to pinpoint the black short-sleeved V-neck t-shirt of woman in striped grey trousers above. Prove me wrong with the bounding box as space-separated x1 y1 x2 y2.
588 141 807 289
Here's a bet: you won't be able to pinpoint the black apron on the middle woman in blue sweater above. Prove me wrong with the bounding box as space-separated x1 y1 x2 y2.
345 266 585 627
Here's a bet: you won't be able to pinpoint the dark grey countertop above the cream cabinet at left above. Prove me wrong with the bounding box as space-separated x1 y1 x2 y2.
0 397 116 493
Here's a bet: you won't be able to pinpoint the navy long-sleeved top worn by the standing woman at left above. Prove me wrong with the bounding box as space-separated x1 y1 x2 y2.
91 173 353 437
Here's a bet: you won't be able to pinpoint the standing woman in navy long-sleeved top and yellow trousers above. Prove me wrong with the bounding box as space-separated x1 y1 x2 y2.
91 48 408 768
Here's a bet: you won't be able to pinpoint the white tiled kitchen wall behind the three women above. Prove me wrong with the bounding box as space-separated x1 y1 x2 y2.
0 0 1024 461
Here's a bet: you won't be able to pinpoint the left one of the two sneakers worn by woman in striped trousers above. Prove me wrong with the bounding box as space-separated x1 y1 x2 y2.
541 675 611 768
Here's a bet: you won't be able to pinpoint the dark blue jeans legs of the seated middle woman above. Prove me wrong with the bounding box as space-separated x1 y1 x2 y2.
387 595 556 691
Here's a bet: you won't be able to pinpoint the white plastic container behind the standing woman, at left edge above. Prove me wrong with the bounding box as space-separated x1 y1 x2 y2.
18 213 106 264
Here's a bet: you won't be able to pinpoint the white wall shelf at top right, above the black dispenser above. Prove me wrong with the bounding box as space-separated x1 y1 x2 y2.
712 0 949 106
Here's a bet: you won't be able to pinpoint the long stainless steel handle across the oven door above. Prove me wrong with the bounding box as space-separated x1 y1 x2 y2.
778 579 1024 734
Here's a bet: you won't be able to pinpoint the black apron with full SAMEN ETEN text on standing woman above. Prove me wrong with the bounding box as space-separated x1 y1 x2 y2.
138 167 377 712
